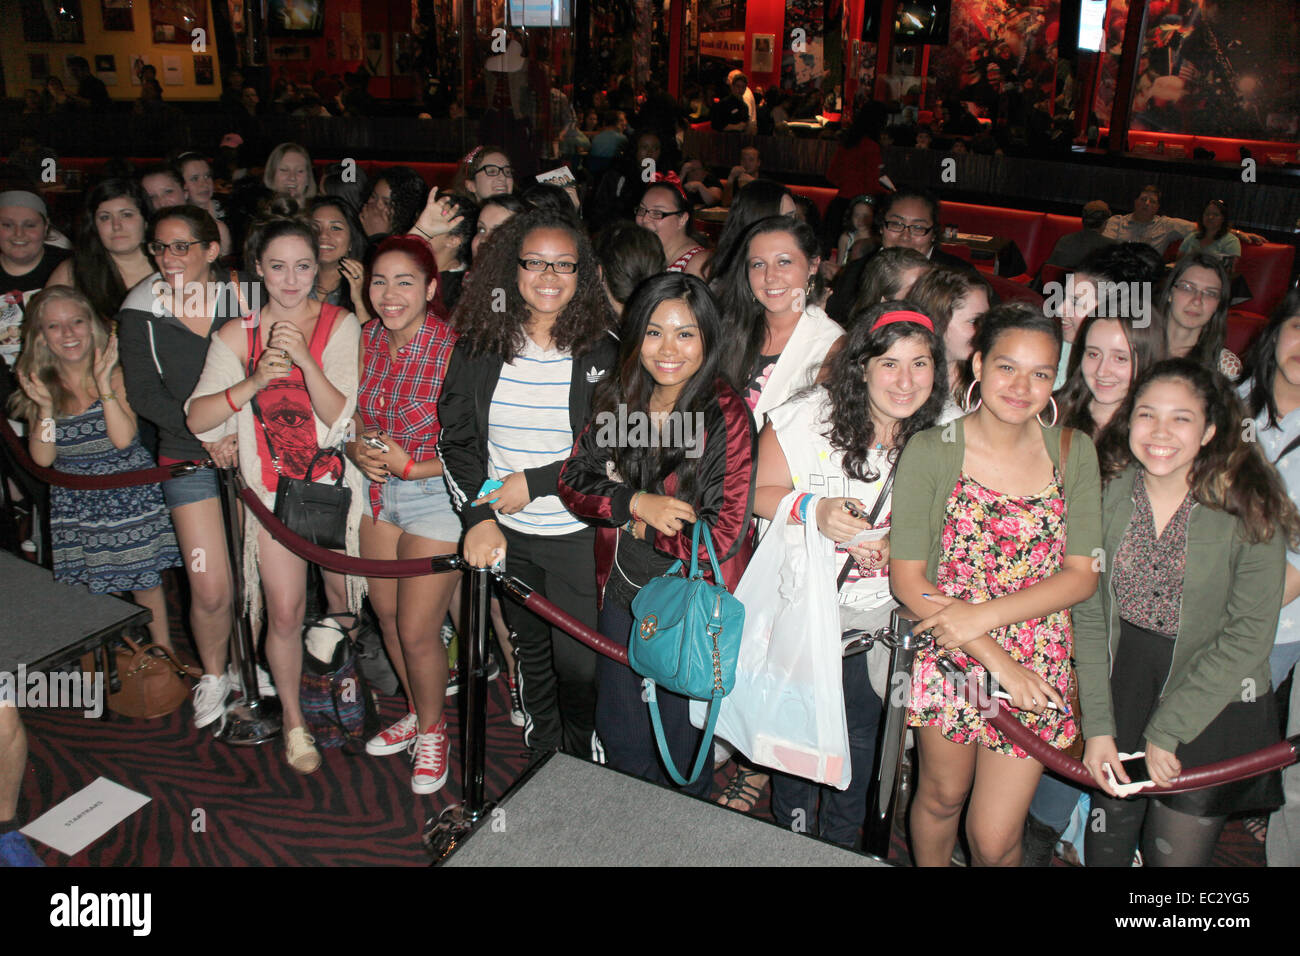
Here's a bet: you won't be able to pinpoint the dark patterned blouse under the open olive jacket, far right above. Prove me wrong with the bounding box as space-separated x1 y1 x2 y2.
1113 471 1196 637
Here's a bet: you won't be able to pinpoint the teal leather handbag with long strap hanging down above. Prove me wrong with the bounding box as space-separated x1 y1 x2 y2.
628 520 745 787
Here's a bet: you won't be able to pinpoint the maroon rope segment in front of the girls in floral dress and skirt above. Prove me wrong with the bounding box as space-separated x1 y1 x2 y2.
936 657 1300 796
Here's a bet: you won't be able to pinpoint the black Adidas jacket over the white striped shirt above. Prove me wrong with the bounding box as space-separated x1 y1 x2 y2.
438 333 619 529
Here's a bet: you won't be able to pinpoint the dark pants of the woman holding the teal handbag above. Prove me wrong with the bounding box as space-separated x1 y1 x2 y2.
595 606 714 797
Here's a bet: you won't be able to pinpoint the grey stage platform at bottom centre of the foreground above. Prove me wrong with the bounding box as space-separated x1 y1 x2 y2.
443 754 887 866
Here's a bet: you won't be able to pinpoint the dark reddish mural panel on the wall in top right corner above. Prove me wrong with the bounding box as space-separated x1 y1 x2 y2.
1131 0 1300 139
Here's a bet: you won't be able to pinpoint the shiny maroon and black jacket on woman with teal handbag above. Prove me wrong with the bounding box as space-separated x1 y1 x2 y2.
559 378 758 605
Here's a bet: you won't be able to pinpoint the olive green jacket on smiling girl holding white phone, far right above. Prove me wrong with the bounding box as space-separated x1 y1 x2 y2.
1074 466 1286 753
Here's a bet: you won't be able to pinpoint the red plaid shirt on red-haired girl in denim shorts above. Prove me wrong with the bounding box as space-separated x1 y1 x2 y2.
356 311 456 515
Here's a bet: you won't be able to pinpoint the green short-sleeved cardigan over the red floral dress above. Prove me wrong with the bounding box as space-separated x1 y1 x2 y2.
889 419 1101 581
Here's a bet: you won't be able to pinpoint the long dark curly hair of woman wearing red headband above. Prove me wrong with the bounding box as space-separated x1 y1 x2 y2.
826 299 948 481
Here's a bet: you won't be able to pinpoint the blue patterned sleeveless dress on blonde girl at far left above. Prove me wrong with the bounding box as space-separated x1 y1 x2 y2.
49 399 181 594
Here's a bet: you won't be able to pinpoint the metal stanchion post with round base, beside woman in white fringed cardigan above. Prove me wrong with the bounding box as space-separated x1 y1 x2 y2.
216 468 280 747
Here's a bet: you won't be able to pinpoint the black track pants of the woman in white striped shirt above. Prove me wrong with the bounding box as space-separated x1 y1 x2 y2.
502 527 597 760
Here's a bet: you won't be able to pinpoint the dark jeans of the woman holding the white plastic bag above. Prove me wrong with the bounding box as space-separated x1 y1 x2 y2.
772 654 884 849
